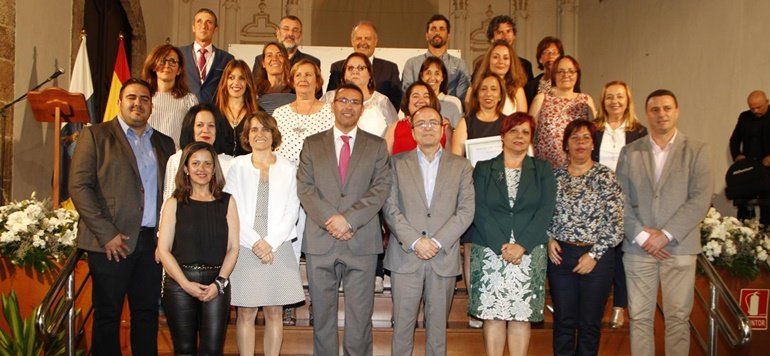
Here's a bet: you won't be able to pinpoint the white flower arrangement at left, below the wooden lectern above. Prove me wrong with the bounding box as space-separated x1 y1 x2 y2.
0 193 78 272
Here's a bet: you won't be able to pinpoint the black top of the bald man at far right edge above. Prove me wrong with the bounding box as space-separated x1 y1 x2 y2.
730 110 770 160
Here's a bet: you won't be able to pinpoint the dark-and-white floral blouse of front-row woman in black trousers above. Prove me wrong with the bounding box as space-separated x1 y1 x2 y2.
547 163 624 260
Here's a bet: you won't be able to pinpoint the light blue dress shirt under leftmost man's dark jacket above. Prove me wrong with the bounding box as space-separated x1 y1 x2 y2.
118 114 158 227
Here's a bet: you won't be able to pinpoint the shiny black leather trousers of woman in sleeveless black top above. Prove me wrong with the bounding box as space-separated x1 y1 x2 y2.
162 268 230 355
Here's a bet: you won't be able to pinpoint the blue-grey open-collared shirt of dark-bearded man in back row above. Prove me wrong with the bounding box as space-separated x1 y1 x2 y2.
401 51 471 98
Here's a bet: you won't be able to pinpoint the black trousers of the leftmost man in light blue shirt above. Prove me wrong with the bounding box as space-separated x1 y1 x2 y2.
88 228 161 356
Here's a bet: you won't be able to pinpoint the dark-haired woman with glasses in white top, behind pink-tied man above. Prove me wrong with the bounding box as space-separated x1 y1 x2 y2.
321 52 398 137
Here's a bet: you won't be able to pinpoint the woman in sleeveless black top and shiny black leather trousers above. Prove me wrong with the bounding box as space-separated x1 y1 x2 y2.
158 142 238 355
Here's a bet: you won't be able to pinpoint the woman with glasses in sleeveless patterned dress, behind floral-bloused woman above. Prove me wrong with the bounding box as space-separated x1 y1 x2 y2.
529 56 596 168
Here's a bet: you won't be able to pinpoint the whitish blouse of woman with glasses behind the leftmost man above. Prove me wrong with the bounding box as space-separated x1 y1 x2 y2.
148 92 198 149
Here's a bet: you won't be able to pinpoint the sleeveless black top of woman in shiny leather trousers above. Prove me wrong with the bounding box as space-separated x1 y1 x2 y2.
171 193 230 266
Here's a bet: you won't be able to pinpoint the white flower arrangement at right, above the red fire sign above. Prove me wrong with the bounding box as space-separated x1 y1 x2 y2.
700 207 770 279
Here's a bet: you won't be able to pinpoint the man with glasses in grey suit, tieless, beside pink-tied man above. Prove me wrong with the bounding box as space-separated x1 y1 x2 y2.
383 106 475 356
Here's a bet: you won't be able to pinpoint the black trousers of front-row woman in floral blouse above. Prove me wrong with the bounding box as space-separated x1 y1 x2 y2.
548 242 615 355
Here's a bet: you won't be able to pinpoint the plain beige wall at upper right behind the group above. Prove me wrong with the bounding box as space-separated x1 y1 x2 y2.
578 0 770 212
